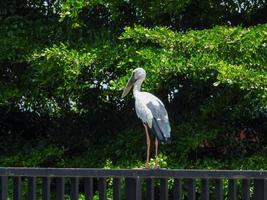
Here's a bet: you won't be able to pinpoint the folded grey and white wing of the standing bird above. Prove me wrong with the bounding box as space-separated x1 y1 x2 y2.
142 93 171 143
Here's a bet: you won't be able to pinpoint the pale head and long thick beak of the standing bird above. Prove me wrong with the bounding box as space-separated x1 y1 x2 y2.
121 67 146 98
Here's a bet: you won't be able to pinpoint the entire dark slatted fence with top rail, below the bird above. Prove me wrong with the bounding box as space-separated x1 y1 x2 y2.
0 167 267 200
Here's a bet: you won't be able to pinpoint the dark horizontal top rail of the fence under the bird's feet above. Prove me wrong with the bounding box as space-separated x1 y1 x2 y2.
0 167 267 179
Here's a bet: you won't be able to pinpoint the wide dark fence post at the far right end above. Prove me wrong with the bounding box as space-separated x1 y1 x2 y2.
253 179 267 200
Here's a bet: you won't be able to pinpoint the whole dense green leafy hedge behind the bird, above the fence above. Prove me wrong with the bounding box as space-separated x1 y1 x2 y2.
0 0 267 173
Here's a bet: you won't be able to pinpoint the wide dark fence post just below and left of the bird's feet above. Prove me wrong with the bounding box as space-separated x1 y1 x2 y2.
125 177 142 200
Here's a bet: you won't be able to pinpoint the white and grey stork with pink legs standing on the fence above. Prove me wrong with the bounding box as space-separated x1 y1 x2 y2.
121 67 171 169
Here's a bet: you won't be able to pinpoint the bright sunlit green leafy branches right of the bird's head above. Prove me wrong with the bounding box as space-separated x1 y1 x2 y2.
122 25 267 100
